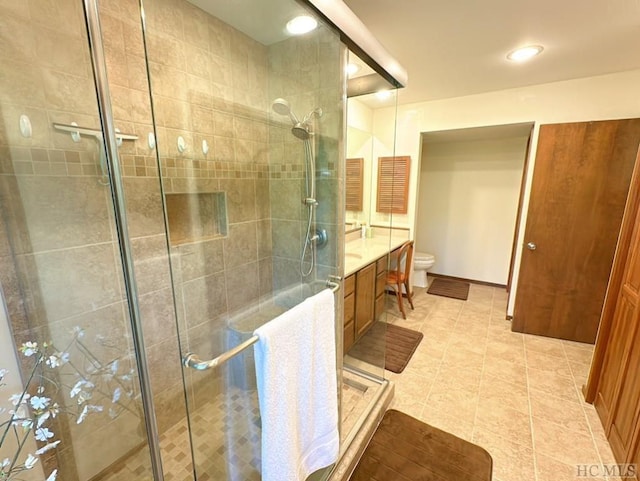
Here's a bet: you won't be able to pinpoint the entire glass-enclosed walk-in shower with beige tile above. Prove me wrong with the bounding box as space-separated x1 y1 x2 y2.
0 0 404 481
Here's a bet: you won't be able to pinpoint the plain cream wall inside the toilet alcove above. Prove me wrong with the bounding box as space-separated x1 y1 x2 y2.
415 137 528 285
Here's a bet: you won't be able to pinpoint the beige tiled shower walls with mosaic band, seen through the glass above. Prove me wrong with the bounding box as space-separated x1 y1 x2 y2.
0 0 342 480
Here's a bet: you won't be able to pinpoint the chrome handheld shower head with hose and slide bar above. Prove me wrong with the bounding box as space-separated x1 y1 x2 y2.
271 98 328 277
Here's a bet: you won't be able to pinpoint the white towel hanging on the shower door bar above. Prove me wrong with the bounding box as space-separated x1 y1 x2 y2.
254 289 340 481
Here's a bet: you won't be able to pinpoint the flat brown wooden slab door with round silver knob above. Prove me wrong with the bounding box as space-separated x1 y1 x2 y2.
512 119 640 343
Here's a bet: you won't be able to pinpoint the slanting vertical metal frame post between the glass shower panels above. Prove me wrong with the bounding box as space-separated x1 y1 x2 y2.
84 0 164 481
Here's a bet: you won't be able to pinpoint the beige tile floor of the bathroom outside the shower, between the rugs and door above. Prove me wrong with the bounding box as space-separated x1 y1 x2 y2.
387 278 617 481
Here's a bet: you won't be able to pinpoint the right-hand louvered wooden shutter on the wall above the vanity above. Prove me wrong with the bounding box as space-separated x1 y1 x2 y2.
376 156 411 214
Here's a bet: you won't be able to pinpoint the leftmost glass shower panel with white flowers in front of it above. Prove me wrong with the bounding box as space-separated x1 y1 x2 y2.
0 0 162 481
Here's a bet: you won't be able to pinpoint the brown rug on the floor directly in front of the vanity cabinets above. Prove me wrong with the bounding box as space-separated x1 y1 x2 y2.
349 322 423 373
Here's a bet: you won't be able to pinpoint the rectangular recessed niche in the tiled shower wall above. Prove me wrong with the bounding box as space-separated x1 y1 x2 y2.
165 192 228 246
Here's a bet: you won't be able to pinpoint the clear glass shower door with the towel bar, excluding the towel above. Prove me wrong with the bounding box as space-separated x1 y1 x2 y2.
144 0 343 480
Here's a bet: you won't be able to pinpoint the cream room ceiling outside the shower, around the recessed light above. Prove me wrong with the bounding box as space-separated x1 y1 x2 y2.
344 0 640 104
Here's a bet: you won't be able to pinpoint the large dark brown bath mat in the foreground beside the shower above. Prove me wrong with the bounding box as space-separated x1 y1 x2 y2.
349 410 493 481
